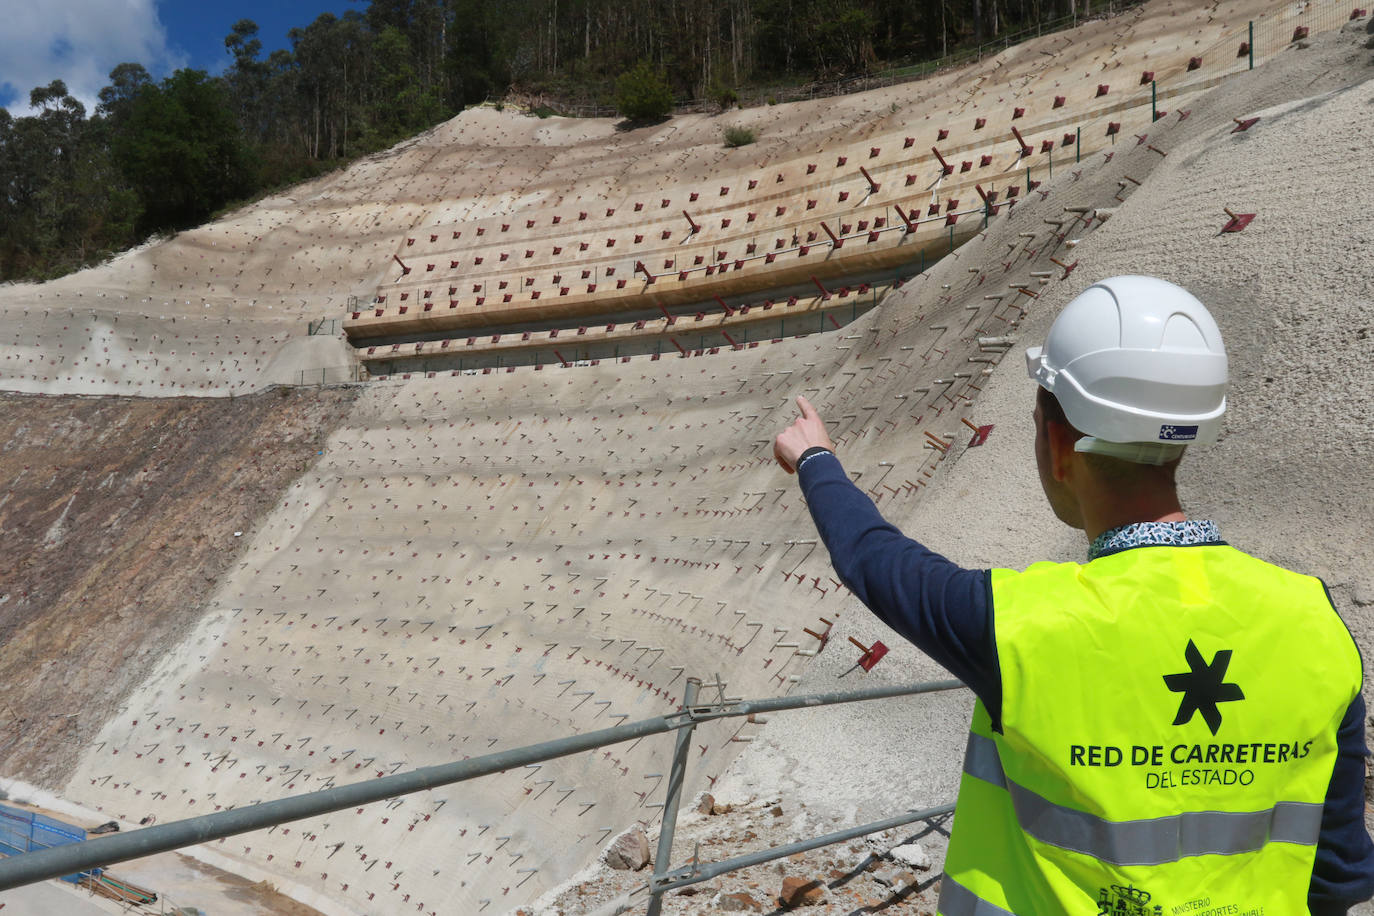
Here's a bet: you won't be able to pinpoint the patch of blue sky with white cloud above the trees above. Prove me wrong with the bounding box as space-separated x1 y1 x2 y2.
0 0 354 115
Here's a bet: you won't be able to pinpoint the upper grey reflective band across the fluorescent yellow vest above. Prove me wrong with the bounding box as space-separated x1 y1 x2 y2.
963 732 1322 865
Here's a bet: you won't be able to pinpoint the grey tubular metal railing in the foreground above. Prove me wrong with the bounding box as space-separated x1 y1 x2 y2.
0 677 965 916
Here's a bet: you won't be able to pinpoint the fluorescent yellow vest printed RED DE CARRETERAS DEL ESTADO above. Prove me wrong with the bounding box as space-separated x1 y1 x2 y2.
938 545 1362 916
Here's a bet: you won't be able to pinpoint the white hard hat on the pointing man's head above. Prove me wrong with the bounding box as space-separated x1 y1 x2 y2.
1026 276 1227 464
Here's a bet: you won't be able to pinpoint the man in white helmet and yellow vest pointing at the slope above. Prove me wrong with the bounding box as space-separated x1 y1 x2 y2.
774 276 1374 916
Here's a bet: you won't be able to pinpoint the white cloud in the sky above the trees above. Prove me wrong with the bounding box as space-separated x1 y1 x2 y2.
0 0 184 115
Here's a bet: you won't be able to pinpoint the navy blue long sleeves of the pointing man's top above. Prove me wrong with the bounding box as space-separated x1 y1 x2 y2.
797 449 1374 916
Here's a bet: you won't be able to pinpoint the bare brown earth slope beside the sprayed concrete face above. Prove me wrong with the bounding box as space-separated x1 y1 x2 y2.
0 389 353 786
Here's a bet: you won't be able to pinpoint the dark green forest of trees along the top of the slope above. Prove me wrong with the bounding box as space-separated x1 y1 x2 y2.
0 0 1124 280
